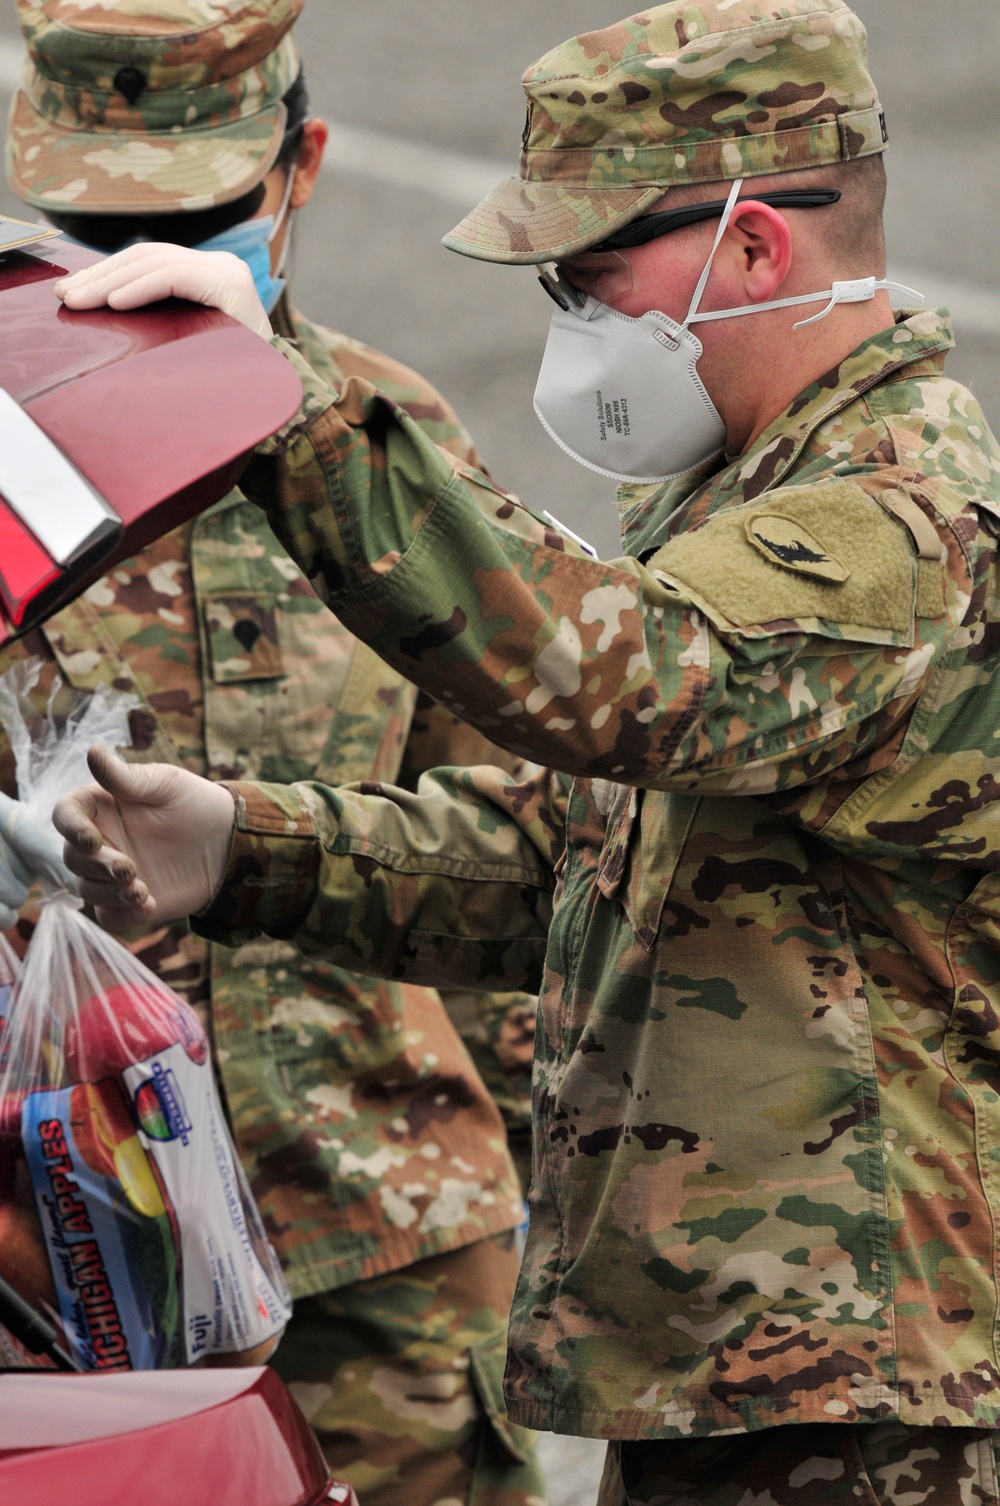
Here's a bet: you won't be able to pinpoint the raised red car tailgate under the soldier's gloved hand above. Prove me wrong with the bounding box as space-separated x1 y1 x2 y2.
0 238 301 640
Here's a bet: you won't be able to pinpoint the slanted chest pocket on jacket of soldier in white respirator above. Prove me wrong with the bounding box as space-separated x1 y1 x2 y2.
598 785 700 952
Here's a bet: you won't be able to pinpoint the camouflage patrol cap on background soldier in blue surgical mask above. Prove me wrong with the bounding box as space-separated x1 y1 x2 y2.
6 0 304 214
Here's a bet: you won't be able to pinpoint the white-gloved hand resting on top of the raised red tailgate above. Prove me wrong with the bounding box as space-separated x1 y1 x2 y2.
56 241 273 340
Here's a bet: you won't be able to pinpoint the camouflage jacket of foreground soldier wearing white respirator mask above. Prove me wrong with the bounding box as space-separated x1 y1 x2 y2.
192 312 1000 1438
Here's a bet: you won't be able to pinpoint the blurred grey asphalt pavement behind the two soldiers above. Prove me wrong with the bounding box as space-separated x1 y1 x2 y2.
0 0 1000 1506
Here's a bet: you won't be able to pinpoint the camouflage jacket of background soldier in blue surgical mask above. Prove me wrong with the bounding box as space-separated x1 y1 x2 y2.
3 299 530 1297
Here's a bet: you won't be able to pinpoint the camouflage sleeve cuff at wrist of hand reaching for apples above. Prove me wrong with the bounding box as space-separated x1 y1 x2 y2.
191 782 321 946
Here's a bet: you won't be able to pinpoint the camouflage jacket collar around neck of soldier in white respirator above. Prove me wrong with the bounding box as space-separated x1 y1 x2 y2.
617 309 955 557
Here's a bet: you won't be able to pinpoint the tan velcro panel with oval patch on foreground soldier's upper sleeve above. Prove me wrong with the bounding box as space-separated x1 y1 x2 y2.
649 480 916 643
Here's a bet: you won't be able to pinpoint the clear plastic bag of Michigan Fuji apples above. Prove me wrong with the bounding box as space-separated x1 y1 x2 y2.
0 665 291 1370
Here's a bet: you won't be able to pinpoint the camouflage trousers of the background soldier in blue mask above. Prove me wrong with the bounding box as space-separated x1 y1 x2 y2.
273 1235 545 1506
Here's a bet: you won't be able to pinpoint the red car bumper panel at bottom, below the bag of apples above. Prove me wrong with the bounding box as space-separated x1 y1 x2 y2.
0 1369 357 1506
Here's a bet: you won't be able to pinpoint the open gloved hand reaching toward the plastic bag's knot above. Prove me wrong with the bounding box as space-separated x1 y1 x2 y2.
53 744 236 931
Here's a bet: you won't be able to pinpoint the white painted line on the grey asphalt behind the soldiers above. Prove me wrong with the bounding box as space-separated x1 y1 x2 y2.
0 38 1000 340
